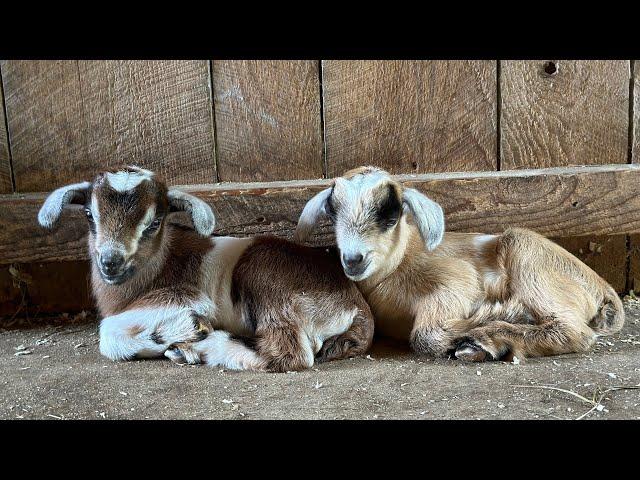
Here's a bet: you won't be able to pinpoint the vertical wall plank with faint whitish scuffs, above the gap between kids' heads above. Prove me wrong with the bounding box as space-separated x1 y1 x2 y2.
213 60 324 182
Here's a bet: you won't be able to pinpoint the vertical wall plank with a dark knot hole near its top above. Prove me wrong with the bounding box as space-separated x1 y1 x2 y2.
500 60 629 170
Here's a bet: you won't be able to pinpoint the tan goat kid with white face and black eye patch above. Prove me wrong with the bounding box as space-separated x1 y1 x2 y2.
296 167 624 361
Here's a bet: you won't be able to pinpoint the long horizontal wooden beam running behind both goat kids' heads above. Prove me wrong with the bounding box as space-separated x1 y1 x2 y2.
0 165 640 264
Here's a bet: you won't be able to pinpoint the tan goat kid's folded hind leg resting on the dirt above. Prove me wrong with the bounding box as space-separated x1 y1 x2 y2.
455 319 596 362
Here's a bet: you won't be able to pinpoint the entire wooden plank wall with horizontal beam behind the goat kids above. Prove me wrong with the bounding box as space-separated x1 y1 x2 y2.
0 60 640 315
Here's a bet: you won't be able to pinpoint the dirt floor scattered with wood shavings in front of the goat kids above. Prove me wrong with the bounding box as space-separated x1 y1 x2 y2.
0 301 640 420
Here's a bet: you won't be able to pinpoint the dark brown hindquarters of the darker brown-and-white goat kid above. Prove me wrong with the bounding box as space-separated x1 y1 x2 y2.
232 237 373 371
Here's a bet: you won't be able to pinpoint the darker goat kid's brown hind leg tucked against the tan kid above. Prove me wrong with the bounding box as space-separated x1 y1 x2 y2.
316 310 374 363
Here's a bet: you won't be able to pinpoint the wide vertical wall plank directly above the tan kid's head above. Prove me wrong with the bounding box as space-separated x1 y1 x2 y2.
322 60 497 176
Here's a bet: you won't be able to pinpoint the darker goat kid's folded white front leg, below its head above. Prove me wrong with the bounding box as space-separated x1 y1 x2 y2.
100 306 209 360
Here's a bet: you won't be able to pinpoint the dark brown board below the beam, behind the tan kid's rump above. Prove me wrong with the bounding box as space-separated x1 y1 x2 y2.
551 235 627 293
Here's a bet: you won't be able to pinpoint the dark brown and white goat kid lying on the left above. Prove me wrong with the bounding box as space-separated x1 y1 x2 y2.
38 167 373 371
